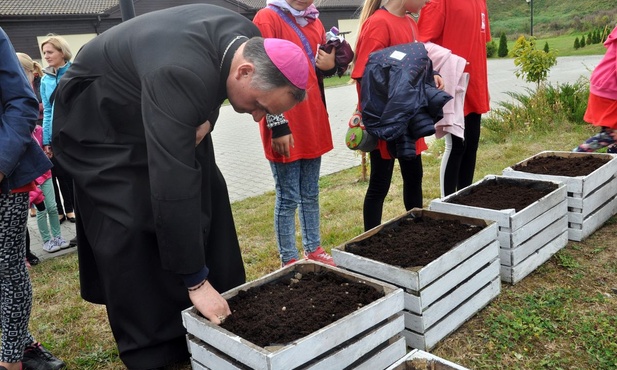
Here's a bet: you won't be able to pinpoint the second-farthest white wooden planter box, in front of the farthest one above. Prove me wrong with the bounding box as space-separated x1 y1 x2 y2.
429 175 568 284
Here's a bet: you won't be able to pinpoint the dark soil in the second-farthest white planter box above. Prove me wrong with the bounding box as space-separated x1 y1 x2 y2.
448 178 557 212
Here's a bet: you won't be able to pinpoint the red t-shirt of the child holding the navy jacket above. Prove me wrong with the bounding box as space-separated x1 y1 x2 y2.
351 9 428 159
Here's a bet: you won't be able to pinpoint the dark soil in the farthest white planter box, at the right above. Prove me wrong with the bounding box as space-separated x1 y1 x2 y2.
512 155 610 177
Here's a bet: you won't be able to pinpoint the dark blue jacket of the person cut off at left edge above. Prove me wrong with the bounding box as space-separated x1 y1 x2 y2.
0 28 51 194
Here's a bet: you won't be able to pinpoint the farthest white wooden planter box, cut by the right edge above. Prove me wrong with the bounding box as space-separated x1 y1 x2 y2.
503 151 617 241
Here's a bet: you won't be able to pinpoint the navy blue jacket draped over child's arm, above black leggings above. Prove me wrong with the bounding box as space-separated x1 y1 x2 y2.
361 42 452 158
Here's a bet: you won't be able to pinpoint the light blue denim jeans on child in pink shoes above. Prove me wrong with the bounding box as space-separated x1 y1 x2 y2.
270 157 321 263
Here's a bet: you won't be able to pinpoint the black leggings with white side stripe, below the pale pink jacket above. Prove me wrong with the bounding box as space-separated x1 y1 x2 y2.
442 113 482 196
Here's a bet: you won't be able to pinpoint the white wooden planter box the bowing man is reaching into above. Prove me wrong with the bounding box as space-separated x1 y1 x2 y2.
182 261 406 370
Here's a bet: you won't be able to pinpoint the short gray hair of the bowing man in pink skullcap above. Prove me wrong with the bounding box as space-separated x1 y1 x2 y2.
242 37 306 102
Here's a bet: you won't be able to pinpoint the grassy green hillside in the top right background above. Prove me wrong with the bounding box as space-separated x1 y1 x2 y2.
487 0 617 37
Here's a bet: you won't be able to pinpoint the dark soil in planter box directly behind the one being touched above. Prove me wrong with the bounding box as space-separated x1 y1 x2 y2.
345 216 483 268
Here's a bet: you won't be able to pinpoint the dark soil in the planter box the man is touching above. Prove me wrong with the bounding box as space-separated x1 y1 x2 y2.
221 271 384 347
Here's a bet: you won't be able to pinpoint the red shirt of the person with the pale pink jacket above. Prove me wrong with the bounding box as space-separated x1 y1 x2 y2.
418 0 491 115
